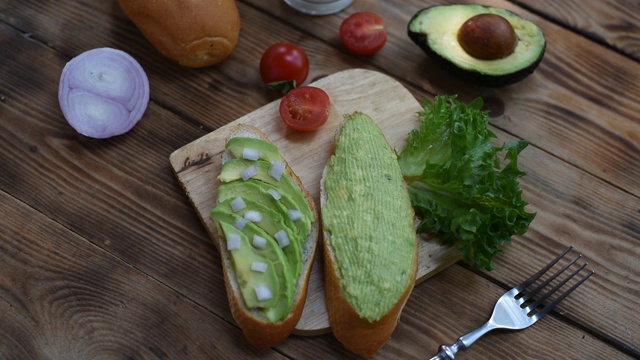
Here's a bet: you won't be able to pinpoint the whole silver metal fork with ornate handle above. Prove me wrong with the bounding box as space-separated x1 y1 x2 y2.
430 246 594 360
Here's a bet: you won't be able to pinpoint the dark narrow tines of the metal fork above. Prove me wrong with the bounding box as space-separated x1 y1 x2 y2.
515 246 594 318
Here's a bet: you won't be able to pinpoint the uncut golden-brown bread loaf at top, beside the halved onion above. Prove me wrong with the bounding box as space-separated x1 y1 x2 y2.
118 0 240 67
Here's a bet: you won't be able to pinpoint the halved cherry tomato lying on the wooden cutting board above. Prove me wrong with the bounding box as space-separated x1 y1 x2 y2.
280 86 331 131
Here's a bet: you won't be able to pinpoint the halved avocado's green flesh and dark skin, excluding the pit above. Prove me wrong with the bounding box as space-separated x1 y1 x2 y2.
408 4 546 87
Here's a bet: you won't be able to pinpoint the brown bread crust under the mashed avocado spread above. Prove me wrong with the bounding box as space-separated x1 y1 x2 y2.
320 115 418 356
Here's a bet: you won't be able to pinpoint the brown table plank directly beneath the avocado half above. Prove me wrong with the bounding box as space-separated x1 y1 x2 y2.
245 0 640 200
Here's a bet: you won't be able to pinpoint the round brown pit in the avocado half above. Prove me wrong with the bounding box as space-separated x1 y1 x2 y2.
458 13 518 60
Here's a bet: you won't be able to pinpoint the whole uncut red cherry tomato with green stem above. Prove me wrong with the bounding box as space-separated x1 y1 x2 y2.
260 41 309 90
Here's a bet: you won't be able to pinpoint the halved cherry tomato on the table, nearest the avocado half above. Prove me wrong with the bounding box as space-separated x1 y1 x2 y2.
340 11 387 55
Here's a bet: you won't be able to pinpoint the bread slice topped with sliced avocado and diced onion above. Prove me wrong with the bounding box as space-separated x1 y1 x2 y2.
210 124 319 347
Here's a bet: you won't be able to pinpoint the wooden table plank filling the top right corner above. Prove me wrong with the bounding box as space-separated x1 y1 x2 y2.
515 0 640 61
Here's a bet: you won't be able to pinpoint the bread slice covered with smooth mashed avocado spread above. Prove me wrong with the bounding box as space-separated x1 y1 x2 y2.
320 112 418 356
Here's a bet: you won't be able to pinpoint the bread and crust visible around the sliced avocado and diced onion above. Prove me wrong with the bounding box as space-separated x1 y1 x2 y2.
212 124 319 347
